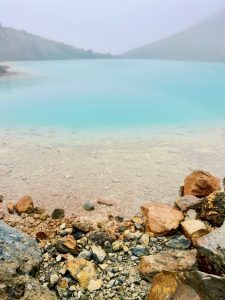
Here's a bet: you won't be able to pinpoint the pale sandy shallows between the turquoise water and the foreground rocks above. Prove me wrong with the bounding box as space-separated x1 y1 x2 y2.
0 127 225 219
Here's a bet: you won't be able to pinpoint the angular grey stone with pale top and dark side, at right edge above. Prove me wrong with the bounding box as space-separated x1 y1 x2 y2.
195 223 225 276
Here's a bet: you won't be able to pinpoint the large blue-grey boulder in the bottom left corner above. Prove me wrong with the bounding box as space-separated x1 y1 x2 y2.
0 221 57 300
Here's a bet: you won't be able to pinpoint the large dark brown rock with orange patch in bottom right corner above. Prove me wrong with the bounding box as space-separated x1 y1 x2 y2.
147 271 225 300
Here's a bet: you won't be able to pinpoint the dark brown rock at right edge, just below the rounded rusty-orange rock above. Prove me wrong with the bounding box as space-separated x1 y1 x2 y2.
200 192 225 226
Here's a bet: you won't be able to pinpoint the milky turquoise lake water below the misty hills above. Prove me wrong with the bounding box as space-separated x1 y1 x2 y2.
0 59 225 129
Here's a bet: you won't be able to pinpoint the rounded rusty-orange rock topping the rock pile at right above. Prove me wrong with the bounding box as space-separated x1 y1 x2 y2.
184 171 221 198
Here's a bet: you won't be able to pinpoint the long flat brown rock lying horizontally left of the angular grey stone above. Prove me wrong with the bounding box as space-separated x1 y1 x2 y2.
139 249 197 281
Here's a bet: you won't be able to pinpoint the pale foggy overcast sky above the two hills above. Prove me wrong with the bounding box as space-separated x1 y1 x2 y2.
0 0 225 53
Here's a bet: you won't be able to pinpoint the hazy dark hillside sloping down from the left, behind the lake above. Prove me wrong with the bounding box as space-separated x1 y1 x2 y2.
0 24 112 61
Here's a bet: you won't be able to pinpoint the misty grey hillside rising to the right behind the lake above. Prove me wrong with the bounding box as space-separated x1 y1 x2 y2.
123 11 225 62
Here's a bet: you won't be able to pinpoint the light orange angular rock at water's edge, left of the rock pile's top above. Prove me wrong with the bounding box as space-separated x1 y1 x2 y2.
141 203 184 236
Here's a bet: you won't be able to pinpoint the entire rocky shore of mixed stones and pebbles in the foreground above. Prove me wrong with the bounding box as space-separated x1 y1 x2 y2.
0 171 225 300
